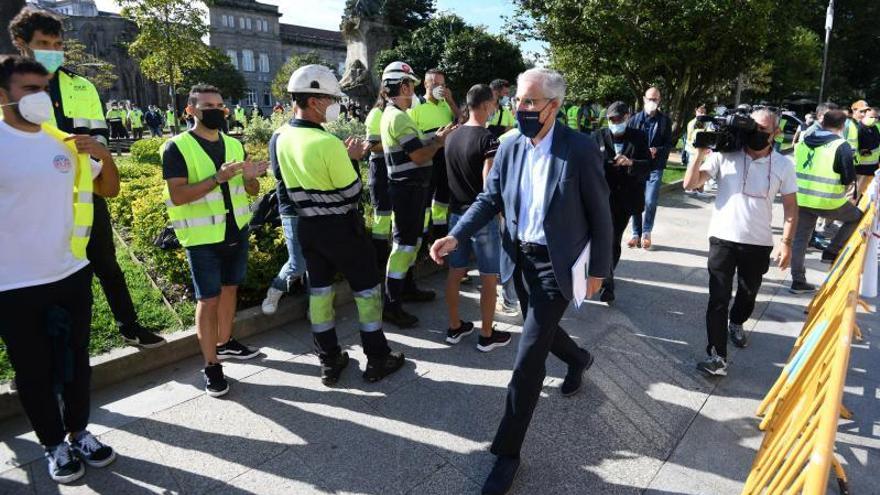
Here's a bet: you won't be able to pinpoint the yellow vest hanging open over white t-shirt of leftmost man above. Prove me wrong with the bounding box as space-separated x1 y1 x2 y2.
42 124 94 259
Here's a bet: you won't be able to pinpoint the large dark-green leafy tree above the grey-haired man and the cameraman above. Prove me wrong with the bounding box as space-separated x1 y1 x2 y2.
517 0 790 134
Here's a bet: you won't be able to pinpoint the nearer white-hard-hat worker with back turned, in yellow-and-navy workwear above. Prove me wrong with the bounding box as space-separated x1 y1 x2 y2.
269 65 404 386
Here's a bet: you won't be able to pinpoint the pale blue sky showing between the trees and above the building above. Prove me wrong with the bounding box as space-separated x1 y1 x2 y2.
96 0 543 56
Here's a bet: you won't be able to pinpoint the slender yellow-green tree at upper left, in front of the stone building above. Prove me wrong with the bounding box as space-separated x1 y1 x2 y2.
116 0 209 106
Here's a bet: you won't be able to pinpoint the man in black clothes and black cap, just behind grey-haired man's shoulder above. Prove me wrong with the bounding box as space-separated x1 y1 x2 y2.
593 101 651 303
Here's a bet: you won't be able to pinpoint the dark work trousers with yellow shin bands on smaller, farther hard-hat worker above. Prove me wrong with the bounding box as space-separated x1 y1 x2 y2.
385 183 428 308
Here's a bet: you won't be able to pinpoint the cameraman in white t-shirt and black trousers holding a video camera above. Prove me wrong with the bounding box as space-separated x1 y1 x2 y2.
684 110 798 376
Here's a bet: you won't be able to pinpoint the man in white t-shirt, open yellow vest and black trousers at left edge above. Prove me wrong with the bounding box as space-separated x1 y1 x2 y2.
0 55 119 483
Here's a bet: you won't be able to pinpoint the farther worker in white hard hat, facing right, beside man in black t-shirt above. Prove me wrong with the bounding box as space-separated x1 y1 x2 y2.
380 62 455 328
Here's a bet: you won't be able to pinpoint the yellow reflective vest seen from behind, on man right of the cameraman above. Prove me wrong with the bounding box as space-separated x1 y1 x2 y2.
794 139 846 210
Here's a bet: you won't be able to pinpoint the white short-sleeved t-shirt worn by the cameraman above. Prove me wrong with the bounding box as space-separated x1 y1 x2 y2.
700 151 797 246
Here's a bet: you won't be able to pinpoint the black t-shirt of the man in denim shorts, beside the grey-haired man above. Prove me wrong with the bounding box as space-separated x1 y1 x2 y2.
444 125 498 211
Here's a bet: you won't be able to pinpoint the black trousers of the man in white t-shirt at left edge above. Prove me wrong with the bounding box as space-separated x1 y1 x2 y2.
0 266 92 447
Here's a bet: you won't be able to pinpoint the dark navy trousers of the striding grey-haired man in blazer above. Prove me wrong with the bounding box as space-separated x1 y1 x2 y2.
492 248 583 456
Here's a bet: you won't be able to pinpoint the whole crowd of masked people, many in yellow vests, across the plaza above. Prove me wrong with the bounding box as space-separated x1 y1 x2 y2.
0 4 880 494
